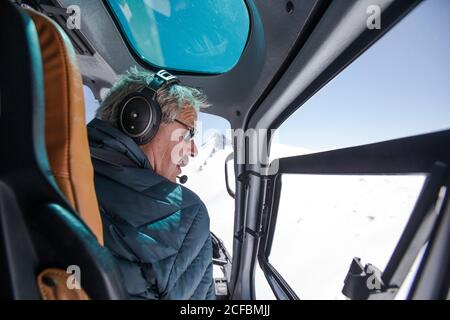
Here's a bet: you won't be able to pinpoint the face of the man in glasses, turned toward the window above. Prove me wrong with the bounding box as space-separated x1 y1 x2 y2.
142 106 197 182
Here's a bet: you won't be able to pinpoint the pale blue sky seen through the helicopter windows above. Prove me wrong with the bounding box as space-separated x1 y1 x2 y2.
85 0 450 151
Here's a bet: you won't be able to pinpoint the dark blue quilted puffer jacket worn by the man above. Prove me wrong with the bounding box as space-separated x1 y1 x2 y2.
88 119 215 300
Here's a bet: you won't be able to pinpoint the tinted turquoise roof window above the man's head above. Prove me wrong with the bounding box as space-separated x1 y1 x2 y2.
108 0 250 73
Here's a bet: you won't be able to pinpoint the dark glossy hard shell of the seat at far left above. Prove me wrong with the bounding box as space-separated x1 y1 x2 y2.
0 1 127 299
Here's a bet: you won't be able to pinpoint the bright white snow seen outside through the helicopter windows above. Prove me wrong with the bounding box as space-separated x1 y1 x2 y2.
183 134 424 299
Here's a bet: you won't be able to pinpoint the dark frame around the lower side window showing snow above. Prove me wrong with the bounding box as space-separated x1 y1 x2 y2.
258 130 450 300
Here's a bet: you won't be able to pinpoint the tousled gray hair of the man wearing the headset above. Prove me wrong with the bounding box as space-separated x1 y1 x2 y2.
96 67 210 127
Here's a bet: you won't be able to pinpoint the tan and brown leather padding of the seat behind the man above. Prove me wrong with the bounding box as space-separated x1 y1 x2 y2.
27 10 103 243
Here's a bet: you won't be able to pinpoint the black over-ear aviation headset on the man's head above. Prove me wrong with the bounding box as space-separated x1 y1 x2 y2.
119 70 180 145
